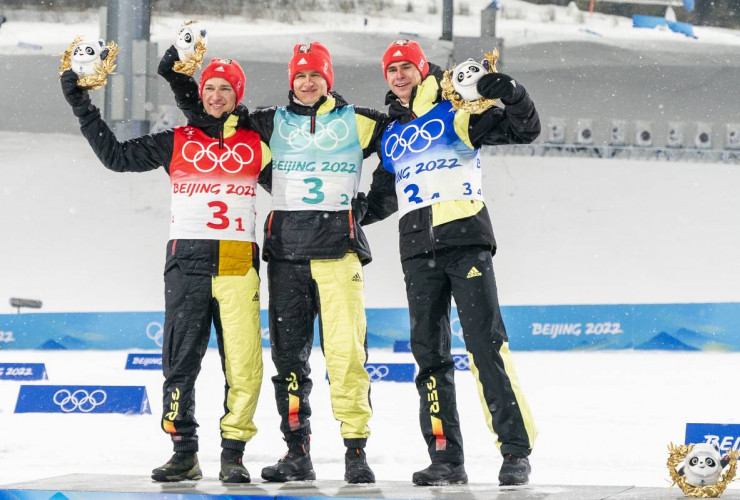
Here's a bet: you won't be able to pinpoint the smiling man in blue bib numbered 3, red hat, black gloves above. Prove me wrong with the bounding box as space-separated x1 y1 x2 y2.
362 40 540 485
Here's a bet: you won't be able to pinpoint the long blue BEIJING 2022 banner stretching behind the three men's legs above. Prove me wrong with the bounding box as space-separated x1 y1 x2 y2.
0 302 740 351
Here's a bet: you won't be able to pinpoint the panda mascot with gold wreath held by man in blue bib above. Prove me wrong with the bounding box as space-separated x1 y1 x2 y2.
440 49 506 114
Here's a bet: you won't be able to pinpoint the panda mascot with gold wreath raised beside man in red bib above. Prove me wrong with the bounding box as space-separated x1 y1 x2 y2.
59 36 119 90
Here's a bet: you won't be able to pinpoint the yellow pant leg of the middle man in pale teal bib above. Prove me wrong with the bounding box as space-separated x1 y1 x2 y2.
311 252 372 439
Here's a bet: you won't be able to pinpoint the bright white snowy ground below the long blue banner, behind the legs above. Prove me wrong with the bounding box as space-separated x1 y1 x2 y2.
0 350 740 488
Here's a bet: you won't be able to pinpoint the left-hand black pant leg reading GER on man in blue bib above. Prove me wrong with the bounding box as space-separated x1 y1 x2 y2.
401 256 464 463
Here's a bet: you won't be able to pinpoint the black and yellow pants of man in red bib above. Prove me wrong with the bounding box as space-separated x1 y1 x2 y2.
162 265 262 451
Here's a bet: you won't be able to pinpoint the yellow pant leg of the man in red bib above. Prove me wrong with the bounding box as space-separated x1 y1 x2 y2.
213 268 262 442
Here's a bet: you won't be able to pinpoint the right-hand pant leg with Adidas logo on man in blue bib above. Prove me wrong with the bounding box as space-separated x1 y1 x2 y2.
448 247 536 456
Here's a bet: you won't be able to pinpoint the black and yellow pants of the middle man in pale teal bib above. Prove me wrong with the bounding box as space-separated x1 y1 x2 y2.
267 252 372 448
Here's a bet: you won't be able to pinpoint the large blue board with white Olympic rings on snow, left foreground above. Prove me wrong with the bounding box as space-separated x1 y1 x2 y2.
15 385 152 414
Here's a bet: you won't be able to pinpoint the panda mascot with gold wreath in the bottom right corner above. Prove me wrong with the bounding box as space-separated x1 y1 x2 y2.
666 443 738 498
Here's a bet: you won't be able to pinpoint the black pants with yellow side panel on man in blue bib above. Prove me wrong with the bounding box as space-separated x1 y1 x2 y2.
401 246 537 463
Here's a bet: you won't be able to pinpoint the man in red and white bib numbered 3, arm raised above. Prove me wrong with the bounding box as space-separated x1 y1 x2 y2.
61 59 271 483
